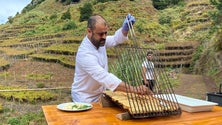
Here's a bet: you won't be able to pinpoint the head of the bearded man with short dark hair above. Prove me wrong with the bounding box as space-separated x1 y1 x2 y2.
87 15 108 49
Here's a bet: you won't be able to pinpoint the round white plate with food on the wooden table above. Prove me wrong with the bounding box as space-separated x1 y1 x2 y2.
57 102 93 111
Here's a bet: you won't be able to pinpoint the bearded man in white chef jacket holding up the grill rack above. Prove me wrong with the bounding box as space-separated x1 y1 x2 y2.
72 14 151 102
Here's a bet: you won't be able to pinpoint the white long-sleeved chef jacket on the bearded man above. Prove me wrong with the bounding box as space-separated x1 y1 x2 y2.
71 29 128 102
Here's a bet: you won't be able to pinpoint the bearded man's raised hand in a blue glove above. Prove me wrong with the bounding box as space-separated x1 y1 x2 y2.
122 14 136 32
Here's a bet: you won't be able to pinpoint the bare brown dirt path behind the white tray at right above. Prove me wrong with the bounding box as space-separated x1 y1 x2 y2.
174 74 217 100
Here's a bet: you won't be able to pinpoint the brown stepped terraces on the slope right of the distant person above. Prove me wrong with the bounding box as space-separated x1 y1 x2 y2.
154 41 199 68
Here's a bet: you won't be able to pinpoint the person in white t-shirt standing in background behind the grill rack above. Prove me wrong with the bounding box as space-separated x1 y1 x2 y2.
142 51 155 91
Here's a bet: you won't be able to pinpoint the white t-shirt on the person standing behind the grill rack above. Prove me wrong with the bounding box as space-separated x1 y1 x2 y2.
142 59 154 80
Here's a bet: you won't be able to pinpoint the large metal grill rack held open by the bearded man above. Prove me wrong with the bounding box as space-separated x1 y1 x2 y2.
108 14 181 118
